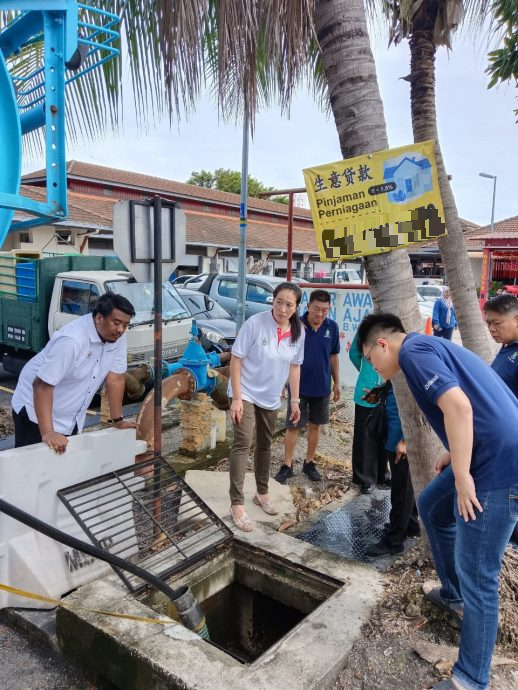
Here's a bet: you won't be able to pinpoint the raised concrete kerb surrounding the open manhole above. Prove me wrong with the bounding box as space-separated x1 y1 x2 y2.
57 525 384 690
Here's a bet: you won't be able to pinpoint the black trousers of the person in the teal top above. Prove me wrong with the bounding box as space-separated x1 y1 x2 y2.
353 405 387 484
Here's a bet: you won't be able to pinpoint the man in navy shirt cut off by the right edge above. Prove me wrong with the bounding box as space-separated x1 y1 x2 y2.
484 293 518 549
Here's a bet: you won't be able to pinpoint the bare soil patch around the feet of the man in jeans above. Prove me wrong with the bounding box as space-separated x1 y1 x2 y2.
334 543 518 690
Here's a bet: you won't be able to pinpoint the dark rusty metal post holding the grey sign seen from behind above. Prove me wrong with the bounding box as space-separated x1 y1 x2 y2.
153 196 162 457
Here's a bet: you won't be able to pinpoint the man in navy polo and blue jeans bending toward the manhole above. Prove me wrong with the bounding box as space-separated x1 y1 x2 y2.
358 314 518 690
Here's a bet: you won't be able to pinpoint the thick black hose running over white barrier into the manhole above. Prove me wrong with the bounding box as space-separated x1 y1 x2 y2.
0 499 209 640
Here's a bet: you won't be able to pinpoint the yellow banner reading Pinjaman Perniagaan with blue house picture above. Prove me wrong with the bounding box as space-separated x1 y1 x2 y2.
304 141 446 261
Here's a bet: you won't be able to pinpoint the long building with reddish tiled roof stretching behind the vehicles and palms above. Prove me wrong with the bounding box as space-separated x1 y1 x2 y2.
11 160 508 281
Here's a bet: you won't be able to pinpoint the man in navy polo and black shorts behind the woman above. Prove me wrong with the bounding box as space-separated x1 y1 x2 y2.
275 290 340 484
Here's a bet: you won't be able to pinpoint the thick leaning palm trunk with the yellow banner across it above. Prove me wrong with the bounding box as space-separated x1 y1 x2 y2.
315 0 440 494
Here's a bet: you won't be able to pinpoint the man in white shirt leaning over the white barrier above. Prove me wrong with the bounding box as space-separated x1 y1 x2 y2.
12 293 135 453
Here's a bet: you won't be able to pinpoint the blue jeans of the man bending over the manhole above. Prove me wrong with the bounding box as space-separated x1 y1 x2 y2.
418 460 518 690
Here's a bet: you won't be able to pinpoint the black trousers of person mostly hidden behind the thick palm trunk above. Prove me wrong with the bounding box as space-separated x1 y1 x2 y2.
385 450 419 546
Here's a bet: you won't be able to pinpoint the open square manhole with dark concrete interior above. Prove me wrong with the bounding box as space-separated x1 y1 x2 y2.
144 541 343 664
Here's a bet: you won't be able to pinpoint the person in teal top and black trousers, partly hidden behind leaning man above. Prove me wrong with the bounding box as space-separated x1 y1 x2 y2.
349 336 388 494
